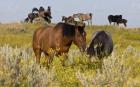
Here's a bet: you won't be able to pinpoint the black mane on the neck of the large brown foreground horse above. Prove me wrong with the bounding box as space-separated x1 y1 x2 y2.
55 22 75 37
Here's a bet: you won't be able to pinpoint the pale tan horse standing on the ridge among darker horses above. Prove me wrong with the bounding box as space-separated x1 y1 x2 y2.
73 13 92 26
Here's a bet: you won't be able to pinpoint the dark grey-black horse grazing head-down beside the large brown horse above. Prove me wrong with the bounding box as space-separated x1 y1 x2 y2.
87 31 113 59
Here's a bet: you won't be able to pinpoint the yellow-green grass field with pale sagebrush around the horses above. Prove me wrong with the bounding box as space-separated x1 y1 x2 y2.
0 23 140 87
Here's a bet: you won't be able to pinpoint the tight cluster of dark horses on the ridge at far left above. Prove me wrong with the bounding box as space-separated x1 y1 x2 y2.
24 6 52 23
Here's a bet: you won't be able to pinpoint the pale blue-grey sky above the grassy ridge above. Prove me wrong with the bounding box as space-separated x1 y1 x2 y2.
0 0 140 27
